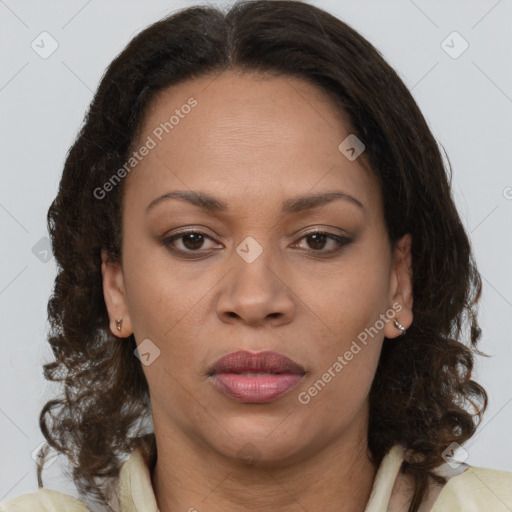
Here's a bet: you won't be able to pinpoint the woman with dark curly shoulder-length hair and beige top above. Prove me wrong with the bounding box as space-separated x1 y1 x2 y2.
1 0 512 512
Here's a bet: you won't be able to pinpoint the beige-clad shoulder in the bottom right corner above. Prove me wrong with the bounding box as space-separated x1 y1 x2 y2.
431 466 512 512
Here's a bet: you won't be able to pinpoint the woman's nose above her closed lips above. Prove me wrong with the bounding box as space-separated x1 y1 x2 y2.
217 241 296 327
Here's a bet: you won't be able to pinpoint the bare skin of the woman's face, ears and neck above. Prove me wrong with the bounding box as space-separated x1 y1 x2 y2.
102 71 413 512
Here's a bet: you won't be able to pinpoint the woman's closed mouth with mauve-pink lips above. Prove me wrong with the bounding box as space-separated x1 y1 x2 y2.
207 351 306 404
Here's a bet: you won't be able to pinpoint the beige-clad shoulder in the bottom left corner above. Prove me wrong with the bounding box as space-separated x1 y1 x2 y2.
0 487 87 512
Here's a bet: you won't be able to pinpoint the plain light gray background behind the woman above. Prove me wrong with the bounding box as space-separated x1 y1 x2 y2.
0 0 512 502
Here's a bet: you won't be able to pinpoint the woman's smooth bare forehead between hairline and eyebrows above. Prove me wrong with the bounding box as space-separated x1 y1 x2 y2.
125 71 379 216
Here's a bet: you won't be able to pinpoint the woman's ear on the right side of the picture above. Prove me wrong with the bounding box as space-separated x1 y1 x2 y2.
384 233 413 338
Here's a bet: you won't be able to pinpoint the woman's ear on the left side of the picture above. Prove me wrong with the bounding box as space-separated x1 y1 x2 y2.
101 249 133 338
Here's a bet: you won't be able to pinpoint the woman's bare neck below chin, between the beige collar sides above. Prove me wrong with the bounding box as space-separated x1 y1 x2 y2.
152 418 376 512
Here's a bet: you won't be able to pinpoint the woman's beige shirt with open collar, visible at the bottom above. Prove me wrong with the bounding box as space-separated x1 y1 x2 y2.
0 445 512 512
